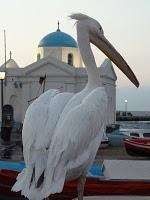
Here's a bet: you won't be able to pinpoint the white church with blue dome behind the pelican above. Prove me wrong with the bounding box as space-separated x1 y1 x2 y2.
0 26 117 124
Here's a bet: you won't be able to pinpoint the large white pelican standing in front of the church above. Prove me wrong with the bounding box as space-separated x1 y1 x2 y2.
12 13 139 200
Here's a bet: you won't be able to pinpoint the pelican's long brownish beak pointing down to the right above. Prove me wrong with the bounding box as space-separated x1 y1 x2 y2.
90 34 139 87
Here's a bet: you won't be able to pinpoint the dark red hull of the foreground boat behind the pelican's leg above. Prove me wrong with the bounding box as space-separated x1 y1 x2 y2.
0 169 150 200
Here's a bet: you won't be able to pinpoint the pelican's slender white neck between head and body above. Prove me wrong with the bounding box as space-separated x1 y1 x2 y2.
77 29 101 88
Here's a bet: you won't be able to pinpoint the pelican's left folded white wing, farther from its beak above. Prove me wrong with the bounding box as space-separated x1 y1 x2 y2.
13 90 73 198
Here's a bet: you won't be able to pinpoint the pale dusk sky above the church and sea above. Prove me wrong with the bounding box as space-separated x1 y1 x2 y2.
0 0 150 111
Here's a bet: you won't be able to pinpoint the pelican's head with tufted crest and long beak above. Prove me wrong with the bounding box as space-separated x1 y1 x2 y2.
70 13 139 87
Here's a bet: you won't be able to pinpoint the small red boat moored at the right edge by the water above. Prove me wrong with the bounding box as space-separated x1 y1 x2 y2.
124 138 150 157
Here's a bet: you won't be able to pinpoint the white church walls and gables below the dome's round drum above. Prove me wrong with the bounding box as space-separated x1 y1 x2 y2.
0 55 116 124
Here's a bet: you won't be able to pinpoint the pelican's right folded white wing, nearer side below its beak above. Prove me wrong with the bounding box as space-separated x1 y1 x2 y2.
43 88 107 196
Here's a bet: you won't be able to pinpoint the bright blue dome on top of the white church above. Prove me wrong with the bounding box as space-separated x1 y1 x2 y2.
38 30 77 48
